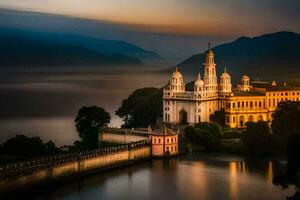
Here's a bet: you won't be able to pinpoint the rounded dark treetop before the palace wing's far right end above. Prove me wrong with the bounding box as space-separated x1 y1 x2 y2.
272 101 300 136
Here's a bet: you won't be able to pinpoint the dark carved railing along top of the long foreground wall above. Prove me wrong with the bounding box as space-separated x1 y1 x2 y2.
0 140 150 178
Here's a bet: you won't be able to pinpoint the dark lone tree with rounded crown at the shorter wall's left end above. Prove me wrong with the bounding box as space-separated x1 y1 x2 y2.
75 106 111 149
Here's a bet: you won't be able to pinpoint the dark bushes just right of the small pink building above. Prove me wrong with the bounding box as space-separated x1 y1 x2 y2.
184 122 222 152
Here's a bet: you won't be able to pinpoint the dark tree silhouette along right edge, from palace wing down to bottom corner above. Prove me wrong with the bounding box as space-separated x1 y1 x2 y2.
272 101 300 199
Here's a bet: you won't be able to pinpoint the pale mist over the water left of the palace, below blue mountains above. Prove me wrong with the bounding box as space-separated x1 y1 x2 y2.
0 66 195 145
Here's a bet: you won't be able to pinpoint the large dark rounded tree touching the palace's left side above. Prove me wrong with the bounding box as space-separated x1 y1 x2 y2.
116 87 163 128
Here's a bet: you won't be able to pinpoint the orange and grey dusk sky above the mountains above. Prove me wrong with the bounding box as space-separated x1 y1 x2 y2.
0 0 300 36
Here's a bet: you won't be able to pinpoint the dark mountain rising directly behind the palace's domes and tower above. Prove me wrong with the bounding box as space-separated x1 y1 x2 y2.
168 32 300 81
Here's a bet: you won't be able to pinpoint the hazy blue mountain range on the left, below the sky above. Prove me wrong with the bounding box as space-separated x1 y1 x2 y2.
0 28 160 66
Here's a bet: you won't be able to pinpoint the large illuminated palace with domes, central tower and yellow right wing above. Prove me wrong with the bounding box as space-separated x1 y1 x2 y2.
163 48 300 128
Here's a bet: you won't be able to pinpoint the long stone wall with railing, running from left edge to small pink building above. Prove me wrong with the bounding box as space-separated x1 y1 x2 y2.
0 140 151 193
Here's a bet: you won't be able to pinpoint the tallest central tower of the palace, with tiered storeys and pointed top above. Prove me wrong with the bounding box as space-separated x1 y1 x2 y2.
203 44 218 98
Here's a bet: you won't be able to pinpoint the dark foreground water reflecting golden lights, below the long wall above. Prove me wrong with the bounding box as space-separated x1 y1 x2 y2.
12 153 295 200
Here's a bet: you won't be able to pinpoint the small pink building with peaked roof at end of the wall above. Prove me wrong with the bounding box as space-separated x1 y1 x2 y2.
150 126 179 157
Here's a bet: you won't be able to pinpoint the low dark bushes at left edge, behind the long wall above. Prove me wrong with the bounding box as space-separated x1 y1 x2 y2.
1 135 60 157
